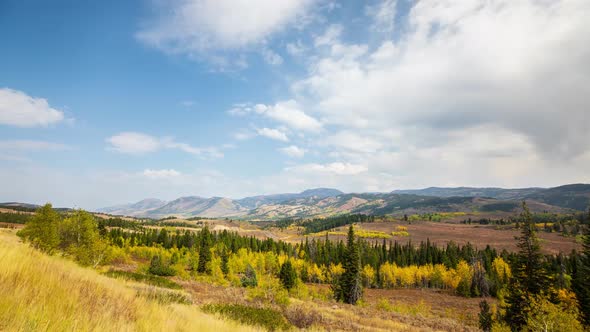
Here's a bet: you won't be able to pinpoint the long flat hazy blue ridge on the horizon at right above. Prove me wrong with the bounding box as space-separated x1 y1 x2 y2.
392 187 546 199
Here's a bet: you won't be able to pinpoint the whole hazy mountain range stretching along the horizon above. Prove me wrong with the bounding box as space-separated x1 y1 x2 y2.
98 184 590 219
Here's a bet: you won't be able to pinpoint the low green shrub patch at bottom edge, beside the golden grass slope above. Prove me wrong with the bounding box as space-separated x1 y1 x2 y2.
202 304 291 331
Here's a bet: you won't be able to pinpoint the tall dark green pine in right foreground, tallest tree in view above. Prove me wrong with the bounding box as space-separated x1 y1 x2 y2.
506 202 549 331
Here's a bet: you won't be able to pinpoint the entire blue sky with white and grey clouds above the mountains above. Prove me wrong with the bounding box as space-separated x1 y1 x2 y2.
0 0 590 209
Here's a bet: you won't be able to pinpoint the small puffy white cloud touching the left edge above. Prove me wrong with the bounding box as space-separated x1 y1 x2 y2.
0 88 64 127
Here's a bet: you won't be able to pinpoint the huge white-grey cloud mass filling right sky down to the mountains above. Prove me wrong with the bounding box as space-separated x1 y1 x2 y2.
247 0 590 191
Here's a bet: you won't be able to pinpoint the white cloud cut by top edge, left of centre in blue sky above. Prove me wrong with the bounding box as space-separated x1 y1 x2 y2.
137 0 316 67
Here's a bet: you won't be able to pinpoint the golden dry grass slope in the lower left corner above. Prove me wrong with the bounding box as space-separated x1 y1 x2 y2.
0 230 252 331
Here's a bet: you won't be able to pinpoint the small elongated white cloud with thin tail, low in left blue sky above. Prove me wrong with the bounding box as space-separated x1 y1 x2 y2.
106 132 223 158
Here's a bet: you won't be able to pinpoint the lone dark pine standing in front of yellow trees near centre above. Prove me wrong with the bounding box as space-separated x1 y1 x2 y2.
334 225 363 305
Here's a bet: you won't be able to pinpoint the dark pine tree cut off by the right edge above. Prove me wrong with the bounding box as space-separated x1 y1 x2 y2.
572 224 590 327
